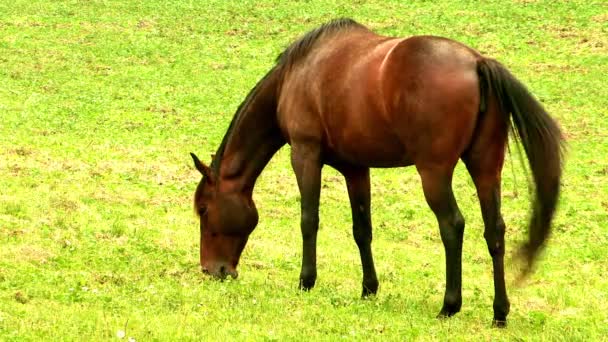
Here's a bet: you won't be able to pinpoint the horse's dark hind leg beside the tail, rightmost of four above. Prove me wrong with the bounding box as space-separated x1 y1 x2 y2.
470 174 510 327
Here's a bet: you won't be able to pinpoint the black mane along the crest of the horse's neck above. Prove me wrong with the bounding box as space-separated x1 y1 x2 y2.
211 18 367 174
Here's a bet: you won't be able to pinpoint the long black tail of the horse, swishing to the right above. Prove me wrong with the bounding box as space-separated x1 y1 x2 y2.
477 58 564 277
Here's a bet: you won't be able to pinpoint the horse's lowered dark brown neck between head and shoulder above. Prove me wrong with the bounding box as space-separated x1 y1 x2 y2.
219 71 285 196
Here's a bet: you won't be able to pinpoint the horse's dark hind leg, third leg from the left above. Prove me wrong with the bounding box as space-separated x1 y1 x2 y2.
418 168 464 317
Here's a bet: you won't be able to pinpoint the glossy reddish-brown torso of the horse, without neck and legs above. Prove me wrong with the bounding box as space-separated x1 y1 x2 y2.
278 32 480 167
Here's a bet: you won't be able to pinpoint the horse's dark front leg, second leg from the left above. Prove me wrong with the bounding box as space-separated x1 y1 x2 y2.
339 167 378 297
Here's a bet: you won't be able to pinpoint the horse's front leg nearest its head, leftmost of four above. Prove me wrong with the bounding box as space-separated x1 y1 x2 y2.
291 144 322 290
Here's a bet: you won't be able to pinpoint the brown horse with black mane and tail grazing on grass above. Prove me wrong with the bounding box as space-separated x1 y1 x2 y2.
192 19 562 326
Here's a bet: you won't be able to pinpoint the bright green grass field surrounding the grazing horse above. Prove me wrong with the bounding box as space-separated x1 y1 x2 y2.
0 0 608 341
